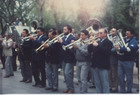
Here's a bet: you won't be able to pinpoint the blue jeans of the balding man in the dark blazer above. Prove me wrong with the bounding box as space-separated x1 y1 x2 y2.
93 68 110 93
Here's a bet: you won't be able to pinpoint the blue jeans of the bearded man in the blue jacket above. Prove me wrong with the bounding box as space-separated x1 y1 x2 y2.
63 63 74 91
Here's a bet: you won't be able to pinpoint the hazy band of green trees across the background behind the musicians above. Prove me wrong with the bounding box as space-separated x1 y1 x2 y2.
0 0 139 38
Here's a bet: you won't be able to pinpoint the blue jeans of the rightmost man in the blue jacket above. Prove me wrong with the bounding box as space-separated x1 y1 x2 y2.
118 60 134 93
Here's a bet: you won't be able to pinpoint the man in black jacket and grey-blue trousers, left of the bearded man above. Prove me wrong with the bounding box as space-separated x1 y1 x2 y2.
44 30 61 91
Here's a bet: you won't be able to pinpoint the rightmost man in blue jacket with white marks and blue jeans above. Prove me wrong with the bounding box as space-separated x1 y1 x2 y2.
115 30 138 93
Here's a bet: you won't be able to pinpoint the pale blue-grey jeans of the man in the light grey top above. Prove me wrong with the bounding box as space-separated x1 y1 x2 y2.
76 62 89 93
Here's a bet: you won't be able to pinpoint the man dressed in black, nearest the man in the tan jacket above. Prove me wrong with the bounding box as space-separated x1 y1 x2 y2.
18 29 32 83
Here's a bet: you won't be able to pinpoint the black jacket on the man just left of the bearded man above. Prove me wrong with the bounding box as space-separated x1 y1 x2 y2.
45 42 61 64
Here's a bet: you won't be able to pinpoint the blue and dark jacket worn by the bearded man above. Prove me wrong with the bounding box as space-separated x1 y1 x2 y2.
61 34 76 63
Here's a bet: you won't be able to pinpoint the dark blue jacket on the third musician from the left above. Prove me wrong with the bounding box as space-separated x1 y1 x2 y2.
32 35 47 62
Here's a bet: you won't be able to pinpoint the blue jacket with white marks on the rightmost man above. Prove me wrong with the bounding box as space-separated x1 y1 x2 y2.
119 37 139 61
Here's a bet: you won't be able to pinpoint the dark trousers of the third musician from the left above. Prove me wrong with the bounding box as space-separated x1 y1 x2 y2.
32 61 46 86
